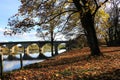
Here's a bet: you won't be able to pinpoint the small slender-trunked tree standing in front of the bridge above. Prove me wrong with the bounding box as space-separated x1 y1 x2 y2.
36 17 59 56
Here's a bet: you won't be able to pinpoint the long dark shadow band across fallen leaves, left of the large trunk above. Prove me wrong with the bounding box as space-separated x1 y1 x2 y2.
24 55 88 69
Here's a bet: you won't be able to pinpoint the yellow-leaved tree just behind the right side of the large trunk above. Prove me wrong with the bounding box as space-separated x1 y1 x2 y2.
95 5 110 43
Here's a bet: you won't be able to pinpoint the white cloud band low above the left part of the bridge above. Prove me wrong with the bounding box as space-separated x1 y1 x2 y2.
0 28 40 42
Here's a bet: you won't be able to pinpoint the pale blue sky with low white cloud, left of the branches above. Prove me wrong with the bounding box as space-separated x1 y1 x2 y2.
0 0 40 42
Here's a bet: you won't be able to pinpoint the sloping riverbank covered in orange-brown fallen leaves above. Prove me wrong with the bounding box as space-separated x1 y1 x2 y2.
3 47 120 80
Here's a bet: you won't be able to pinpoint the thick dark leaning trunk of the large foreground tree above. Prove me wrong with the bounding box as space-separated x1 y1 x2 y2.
73 0 101 56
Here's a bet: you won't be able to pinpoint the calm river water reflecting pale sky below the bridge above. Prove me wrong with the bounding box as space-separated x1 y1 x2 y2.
3 49 66 72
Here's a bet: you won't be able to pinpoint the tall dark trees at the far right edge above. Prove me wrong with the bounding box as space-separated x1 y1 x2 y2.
109 0 120 45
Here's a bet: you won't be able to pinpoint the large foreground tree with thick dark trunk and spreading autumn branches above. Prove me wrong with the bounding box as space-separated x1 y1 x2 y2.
7 0 108 55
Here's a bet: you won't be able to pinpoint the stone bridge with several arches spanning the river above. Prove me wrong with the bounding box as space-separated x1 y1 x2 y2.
0 41 69 59
